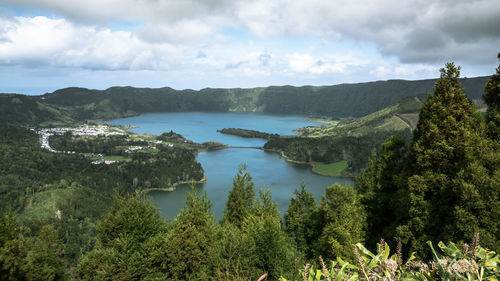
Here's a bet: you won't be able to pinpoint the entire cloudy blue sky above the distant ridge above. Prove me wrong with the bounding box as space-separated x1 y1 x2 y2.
0 0 500 94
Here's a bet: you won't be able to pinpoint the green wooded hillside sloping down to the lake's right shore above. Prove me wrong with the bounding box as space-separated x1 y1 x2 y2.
264 95 420 173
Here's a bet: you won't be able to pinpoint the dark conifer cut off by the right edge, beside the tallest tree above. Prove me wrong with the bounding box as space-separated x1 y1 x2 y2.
483 53 500 138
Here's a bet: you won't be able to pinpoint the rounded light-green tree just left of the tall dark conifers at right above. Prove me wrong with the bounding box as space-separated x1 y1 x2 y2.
316 183 366 261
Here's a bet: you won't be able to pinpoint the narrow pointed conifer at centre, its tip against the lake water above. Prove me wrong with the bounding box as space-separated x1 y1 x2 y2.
222 164 255 227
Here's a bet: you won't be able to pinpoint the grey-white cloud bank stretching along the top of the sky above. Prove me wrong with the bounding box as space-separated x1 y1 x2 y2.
3 0 500 64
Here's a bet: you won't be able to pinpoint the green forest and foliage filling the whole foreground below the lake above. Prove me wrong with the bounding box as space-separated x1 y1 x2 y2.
0 56 500 281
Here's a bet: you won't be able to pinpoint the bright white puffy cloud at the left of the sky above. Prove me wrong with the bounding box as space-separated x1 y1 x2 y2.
0 16 180 70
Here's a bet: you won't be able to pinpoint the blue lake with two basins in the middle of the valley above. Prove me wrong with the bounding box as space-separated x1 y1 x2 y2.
107 112 353 219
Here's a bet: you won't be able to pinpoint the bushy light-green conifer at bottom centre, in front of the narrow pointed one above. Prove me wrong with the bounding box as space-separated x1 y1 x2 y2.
214 188 302 280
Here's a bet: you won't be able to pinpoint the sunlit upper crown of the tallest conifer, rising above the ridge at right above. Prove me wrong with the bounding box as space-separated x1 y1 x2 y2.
412 63 479 175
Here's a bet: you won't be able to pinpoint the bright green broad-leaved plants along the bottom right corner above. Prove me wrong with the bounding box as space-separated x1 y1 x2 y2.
280 240 500 281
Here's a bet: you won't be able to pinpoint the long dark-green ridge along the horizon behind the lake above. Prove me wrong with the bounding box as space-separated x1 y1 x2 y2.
0 77 489 123
